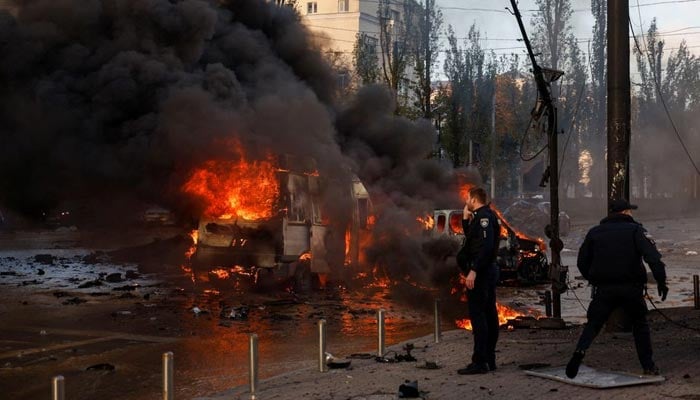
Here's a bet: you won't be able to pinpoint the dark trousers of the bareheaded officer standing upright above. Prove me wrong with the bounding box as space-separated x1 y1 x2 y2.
467 267 498 364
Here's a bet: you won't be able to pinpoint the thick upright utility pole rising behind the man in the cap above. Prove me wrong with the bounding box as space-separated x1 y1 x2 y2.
608 0 631 206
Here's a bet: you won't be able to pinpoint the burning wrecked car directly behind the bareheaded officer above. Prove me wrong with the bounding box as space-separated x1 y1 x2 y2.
431 207 549 284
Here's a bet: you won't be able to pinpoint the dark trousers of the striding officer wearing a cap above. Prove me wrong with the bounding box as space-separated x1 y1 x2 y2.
576 285 654 369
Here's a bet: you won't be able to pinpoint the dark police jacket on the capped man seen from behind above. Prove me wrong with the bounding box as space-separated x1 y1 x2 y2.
577 213 666 285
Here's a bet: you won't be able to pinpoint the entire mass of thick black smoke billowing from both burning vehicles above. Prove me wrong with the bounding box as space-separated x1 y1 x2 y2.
0 0 476 282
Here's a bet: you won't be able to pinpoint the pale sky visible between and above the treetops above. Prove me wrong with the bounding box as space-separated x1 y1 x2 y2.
437 0 700 80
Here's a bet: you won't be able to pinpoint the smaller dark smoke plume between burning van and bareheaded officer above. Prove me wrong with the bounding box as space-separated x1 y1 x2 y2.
336 86 480 281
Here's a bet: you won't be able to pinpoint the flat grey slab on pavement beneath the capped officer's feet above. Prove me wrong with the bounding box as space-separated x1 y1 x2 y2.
525 365 666 389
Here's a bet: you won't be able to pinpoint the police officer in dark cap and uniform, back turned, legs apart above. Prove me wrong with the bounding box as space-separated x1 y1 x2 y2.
566 199 668 378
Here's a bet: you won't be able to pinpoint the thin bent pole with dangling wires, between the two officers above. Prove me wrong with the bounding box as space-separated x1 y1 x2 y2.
510 0 568 319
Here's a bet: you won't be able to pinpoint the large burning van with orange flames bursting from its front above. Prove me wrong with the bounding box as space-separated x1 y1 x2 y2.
185 156 371 282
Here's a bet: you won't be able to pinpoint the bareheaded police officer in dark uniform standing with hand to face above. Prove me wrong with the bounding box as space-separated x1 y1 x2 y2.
457 188 500 375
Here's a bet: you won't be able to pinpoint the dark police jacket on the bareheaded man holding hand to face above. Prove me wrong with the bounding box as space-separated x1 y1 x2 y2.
457 205 500 277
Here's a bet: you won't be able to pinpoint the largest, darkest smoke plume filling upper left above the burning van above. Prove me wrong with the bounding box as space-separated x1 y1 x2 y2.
0 0 342 219
